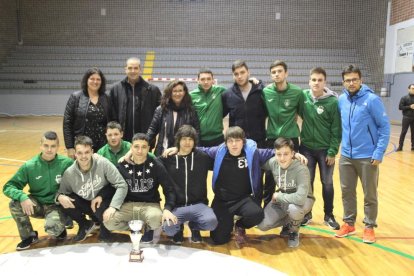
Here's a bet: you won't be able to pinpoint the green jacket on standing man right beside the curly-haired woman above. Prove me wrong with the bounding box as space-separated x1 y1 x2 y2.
190 85 226 141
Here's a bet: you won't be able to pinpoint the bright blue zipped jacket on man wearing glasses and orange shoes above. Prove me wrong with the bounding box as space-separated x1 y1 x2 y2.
338 84 390 161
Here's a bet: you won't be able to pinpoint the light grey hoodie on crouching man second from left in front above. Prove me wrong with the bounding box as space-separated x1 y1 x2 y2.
58 154 128 209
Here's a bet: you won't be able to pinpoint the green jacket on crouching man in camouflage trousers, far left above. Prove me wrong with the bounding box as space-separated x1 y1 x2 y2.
3 154 73 204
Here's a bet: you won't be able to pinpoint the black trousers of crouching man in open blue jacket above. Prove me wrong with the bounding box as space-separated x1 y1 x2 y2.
210 196 264 244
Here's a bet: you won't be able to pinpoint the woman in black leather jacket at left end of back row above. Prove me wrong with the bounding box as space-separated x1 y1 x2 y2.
63 68 112 158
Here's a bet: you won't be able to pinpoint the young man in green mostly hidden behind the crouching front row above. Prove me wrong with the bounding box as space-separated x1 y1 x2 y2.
97 121 131 166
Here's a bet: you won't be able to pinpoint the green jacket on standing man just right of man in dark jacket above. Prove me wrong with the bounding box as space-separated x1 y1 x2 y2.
263 83 303 139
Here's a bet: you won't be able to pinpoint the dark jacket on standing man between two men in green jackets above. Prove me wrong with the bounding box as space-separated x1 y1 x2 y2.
222 82 267 146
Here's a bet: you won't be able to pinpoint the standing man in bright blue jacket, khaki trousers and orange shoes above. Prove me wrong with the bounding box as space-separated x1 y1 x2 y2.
336 65 390 243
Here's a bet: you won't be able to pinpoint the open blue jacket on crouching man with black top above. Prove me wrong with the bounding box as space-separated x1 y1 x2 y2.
199 139 274 198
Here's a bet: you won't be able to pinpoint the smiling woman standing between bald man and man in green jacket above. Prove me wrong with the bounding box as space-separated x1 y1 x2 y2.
147 80 200 156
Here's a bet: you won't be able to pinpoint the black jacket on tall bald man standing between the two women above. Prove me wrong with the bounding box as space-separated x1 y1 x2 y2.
109 78 161 141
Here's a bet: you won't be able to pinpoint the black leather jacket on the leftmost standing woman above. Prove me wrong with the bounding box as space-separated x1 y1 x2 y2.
63 91 112 149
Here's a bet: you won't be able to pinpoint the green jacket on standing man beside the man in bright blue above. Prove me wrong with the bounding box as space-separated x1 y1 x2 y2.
299 88 342 157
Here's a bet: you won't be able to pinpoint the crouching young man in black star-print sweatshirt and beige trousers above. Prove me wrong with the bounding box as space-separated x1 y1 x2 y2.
104 133 177 243
